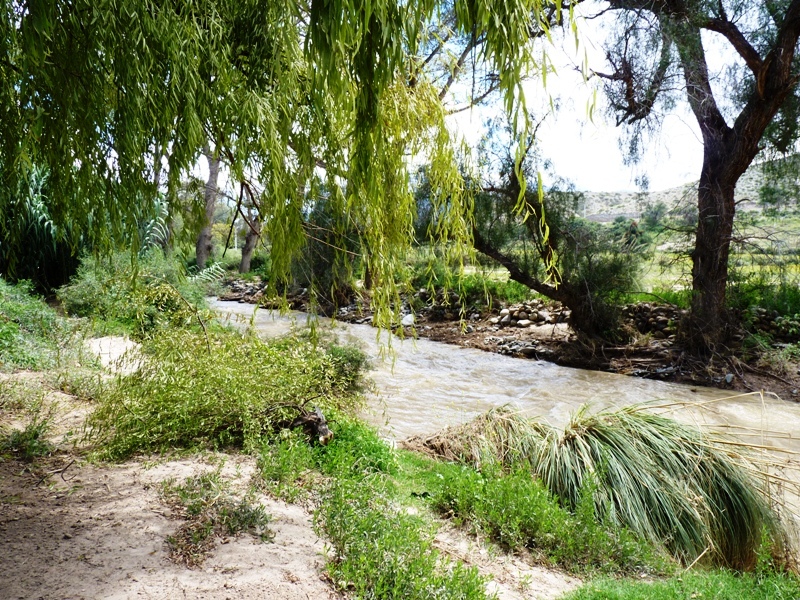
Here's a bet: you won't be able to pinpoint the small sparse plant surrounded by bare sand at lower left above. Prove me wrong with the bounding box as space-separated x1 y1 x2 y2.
162 470 272 567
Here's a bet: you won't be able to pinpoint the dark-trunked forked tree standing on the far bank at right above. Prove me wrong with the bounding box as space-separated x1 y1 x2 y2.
597 0 800 351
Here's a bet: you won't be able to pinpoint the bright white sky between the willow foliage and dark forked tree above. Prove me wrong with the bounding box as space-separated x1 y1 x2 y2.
451 3 703 192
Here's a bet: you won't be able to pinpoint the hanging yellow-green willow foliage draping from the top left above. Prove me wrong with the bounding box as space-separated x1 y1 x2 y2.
0 0 572 322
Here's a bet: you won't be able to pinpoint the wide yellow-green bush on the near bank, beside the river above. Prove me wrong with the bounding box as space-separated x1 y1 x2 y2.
88 330 368 459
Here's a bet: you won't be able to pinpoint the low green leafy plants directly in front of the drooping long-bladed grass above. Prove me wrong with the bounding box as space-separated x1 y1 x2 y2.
432 465 668 573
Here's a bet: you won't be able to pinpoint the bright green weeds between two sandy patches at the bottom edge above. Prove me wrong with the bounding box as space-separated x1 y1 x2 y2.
315 479 487 600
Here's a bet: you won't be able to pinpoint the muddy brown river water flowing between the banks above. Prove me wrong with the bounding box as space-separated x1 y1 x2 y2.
212 301 800 458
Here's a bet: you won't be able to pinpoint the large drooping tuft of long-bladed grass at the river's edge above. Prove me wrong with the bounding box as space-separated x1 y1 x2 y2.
408 406 788 570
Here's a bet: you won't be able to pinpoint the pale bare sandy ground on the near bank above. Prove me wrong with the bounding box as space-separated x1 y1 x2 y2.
0 338 580 600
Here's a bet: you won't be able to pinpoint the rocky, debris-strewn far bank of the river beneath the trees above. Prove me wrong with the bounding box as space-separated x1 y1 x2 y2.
220 280 800 401
